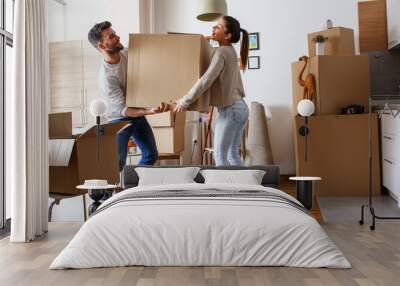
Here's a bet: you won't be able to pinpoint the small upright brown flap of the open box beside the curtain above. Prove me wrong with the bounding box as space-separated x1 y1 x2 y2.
49 112 72 139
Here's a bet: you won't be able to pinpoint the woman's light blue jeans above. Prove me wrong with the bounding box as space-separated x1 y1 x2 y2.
214 99 249 166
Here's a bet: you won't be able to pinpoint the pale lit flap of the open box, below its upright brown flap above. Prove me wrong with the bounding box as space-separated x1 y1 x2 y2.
49 139 75 167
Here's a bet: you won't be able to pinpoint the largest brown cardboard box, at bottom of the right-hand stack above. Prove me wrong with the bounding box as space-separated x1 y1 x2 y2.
294 114 380 196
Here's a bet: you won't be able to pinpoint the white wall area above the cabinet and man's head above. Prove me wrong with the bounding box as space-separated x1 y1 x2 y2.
48 0 139 46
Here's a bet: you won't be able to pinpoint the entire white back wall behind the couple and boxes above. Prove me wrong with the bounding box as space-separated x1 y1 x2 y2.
48 0 358 220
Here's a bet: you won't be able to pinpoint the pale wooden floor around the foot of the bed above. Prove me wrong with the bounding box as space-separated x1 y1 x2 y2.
0 222 400 286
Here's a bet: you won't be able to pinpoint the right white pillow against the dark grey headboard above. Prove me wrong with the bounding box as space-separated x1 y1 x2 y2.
200 170 265 185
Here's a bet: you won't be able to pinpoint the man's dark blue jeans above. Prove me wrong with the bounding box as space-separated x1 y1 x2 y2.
111 117 158 171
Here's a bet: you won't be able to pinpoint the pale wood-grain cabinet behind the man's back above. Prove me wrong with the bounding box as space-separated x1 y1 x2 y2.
49 41 102 127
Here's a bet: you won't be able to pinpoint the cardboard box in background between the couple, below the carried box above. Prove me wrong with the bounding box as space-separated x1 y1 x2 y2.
153 109 186 154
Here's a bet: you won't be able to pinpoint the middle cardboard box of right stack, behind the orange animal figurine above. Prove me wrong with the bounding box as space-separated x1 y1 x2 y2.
292 56 370 115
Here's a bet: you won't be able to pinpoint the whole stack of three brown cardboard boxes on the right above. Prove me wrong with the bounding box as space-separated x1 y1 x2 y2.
292 27 380 196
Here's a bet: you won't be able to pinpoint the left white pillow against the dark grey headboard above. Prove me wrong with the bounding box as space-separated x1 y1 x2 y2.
135 167 200 186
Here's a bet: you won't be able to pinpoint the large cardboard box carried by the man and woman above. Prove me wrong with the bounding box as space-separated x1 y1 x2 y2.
126 34 214 112
